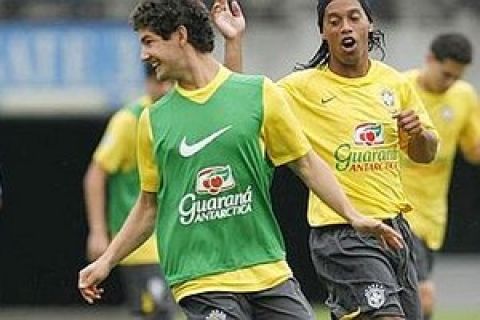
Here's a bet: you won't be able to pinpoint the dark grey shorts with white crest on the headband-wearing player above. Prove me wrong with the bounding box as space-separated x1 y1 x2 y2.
310 215 421 320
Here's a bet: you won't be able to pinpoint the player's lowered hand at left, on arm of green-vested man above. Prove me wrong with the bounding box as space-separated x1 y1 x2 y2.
78 258 111 304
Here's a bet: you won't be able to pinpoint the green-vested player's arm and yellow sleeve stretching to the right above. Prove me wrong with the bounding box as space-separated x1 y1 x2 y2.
262 80 402 248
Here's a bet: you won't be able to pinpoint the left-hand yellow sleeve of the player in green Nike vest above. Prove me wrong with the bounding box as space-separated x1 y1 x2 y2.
137 108 160 192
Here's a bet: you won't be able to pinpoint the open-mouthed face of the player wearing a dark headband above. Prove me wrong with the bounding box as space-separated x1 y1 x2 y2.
322 0 372 68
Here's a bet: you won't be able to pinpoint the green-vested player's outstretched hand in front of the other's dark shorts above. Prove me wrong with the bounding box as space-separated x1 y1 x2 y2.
351 215 404 249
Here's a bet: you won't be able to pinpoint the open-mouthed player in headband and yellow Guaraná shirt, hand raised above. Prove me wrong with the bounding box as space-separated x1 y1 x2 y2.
216 0 437 320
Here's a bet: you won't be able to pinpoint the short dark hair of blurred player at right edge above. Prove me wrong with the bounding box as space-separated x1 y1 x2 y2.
430 33 473 64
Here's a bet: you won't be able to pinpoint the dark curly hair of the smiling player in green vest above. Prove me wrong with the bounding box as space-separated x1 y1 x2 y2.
130 0 215 53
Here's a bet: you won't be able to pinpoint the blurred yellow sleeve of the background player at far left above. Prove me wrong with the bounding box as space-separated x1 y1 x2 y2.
93 111 137 173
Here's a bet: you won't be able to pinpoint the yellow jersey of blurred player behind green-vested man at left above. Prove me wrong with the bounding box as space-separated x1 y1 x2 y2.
93 96 158 265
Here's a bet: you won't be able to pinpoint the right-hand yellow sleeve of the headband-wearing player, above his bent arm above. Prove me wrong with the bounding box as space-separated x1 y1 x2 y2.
400 77 439 151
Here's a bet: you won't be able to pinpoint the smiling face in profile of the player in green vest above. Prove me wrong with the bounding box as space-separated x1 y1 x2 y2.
138 27 186 81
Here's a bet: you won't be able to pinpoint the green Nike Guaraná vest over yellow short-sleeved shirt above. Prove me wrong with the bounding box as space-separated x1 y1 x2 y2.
138 67 311 300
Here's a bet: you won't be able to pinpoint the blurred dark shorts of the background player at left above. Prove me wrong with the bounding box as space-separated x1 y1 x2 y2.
120 264 178 320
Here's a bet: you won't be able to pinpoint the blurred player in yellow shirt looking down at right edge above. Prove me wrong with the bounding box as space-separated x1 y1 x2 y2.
402 33 480 320
